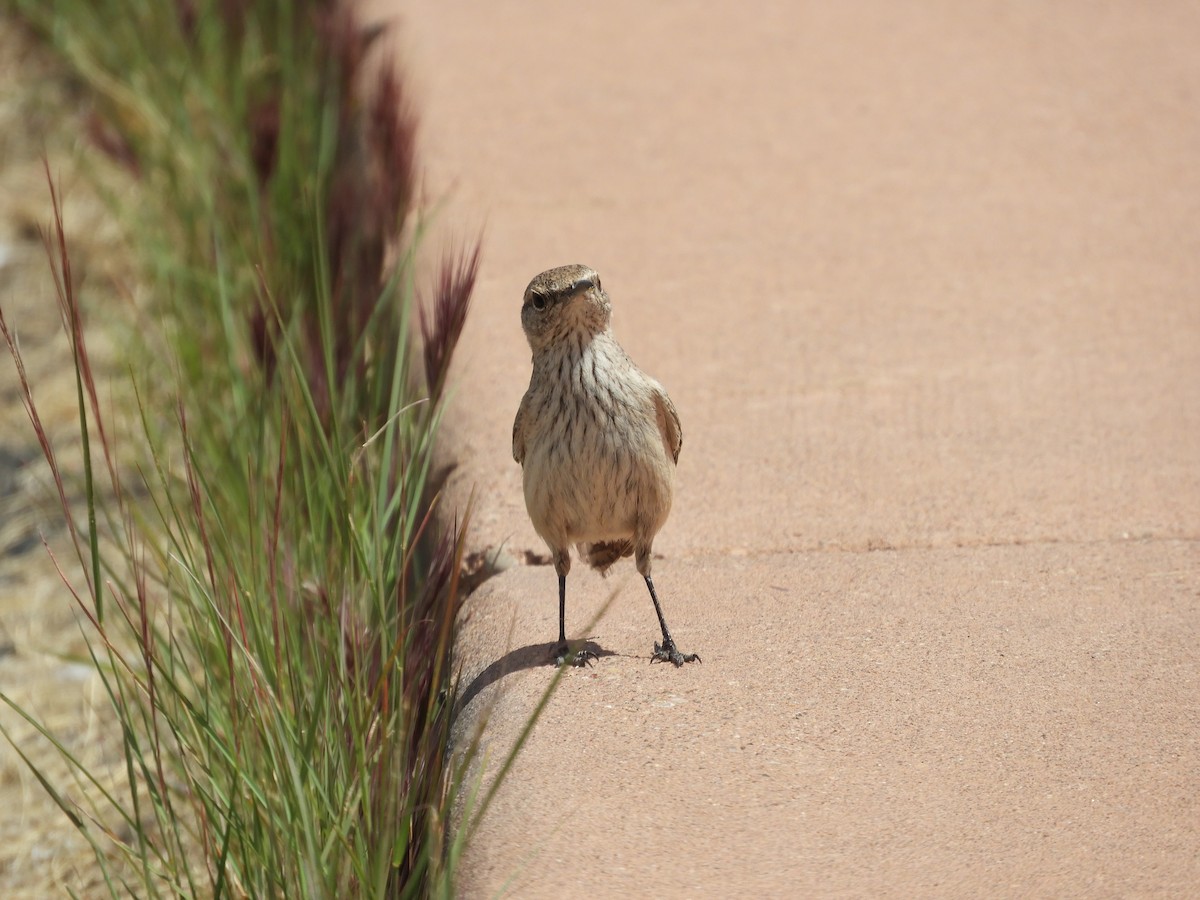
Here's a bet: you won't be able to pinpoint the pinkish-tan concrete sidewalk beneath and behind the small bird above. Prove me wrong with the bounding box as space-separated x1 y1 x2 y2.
372 0 1200 898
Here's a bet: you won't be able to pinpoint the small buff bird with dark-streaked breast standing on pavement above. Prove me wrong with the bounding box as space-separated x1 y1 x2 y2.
512 265 700 666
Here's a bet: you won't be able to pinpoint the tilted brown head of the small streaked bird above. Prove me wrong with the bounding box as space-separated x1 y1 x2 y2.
521 265 612 353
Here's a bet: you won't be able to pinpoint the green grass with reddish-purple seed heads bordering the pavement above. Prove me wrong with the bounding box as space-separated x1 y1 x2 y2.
0 0 478 898
